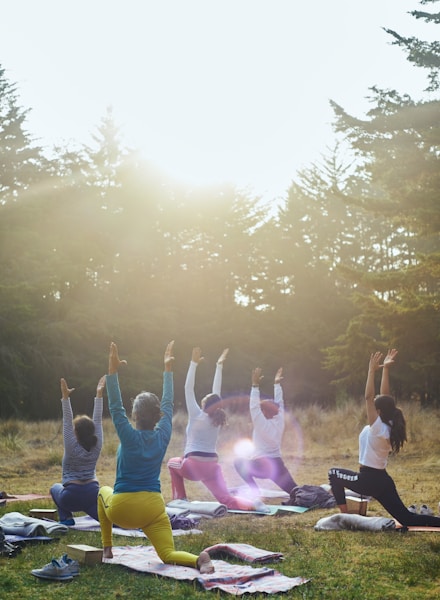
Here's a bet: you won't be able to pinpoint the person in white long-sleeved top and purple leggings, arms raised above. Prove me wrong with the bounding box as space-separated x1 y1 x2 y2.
234 367 297 497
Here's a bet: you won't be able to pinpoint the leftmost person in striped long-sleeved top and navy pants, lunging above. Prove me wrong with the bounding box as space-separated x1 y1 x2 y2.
50 377 105 525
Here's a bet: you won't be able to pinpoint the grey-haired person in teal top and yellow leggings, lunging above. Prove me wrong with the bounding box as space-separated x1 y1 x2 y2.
98 342 214 573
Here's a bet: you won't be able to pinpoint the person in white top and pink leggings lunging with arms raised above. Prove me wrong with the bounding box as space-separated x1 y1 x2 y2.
168 347 263 510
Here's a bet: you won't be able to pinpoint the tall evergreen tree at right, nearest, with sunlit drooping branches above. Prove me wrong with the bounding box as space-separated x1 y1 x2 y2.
327 2 440 402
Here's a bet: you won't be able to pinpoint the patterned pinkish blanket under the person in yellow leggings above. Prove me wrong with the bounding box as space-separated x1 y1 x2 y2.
103 546 309 596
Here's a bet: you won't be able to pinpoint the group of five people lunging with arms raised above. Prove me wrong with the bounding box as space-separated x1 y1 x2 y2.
50 342 440 573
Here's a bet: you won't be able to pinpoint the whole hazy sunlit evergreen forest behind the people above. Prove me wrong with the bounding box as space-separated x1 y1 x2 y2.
0 0 440 419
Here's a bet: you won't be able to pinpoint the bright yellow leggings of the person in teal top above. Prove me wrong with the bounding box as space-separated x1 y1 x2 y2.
98 486 198 567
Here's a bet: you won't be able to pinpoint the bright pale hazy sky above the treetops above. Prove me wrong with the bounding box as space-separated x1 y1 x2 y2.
0 0 438 201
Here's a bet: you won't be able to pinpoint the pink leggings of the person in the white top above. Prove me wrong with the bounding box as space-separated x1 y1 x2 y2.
168 456 255 510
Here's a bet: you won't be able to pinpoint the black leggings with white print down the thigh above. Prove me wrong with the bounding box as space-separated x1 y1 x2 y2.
328 467 440 527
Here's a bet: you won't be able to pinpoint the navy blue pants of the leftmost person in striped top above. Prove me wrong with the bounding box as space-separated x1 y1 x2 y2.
50 481 99 521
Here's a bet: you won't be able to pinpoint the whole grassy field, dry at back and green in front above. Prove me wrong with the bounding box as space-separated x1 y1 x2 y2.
0 402 440 600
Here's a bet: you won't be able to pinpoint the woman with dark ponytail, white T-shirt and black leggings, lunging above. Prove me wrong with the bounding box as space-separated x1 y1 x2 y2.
329 349 440 527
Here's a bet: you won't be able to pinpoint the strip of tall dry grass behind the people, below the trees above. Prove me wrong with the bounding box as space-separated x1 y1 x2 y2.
0 402 440 506
